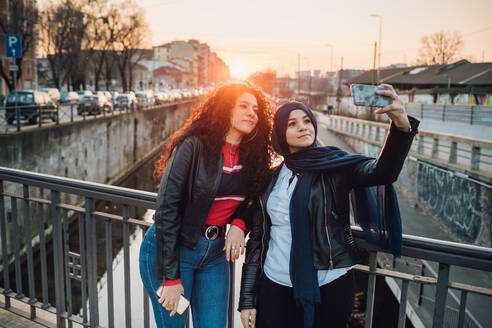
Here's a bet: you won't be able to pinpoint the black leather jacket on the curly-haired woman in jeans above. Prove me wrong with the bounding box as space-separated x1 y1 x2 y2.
154 137 244 280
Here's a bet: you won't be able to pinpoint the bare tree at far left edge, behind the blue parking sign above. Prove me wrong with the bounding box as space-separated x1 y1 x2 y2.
0 0 38 90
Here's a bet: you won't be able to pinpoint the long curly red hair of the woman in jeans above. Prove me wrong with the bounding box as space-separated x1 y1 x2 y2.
154 82 274 197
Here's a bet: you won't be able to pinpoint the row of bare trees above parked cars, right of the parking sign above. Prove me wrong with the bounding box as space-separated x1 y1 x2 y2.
38 0 149 90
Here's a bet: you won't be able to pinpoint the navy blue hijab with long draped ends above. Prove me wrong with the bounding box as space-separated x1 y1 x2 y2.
272 102 402 328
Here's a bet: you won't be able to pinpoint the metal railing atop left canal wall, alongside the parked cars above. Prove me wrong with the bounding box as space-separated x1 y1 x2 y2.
0 98 196 133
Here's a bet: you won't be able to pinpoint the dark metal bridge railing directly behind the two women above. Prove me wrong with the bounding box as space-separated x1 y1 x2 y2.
0 167 492 327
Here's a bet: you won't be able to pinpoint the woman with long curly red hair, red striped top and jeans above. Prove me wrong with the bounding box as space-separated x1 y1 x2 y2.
140 83 272 328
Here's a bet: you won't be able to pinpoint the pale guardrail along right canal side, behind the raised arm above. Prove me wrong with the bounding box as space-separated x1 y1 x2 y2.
327 115 492 181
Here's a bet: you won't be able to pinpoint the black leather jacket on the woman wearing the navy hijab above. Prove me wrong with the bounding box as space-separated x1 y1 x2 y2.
238 117 419 311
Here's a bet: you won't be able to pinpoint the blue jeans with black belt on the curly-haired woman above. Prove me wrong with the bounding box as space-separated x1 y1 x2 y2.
139 225 230 328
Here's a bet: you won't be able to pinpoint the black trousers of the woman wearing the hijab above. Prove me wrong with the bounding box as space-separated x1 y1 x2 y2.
256 270 355 328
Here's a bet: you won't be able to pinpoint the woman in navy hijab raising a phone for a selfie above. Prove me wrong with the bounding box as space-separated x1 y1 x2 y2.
239 85 419 328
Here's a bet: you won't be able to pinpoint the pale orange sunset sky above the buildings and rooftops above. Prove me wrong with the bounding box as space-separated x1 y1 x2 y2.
141 0 492 75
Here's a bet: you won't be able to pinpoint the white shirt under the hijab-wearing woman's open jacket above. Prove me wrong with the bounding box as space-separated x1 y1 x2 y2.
264 164 352 287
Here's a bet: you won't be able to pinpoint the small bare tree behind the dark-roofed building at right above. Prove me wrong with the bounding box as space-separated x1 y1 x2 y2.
416 31 463 65
